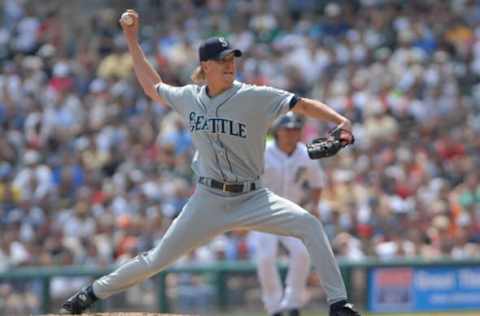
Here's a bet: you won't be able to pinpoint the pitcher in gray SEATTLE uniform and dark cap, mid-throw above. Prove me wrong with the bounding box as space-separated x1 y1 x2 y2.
62 10 359 316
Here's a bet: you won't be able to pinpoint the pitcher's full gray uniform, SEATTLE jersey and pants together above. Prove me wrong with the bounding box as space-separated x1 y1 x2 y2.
93 81 347 303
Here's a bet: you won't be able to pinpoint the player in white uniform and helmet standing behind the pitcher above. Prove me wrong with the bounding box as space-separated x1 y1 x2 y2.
252 112 324 316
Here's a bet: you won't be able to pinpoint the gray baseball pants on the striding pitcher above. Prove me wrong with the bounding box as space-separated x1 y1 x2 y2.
93 184 347 304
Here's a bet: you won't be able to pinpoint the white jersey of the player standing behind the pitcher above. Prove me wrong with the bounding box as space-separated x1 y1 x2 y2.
263 142 325 204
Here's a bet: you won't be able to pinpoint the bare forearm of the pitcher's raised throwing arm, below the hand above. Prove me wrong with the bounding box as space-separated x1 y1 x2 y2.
127 40 162 99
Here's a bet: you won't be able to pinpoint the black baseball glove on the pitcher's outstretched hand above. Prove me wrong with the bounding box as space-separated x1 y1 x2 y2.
307 127 355 159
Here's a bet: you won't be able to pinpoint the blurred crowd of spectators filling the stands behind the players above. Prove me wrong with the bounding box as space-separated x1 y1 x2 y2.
0 0 480 314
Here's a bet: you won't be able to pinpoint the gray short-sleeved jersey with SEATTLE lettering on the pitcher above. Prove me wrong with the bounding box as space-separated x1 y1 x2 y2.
156 81 294 183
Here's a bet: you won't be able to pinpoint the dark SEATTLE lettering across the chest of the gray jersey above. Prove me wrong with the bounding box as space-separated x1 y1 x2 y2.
189 112 247 138
